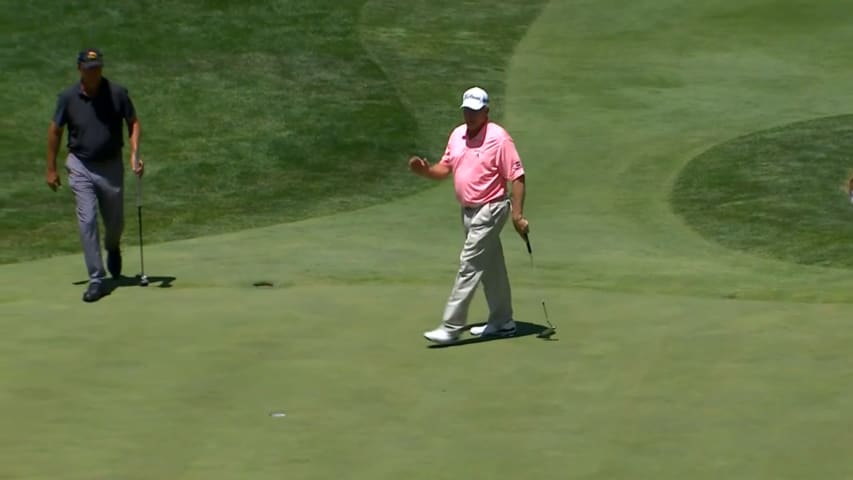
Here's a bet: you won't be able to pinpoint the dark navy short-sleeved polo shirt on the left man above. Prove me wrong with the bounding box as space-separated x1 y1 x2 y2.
53 77 136 162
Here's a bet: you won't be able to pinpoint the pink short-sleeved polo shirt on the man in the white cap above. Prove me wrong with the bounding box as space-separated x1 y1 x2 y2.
439 122 524 206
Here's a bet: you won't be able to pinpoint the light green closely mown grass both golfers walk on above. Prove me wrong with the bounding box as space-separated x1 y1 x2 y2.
0 0 853 479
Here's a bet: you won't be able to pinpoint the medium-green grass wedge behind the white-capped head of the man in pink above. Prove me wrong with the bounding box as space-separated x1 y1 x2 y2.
360 0 548 145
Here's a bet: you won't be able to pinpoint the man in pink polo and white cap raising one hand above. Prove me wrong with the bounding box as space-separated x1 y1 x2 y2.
409 87 529 344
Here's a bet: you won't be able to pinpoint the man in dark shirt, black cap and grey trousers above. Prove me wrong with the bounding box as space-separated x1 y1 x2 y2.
47 49 143 302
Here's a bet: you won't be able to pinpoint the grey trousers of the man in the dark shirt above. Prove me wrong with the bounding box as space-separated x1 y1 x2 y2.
65 154 124 282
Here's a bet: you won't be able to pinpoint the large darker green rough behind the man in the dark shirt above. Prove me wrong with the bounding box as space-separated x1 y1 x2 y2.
0 0 543 263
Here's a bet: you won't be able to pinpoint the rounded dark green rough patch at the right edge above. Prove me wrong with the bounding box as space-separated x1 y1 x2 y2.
671 115 853 267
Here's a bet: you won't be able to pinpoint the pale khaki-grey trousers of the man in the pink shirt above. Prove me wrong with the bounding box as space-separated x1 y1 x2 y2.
442 200 513 332
